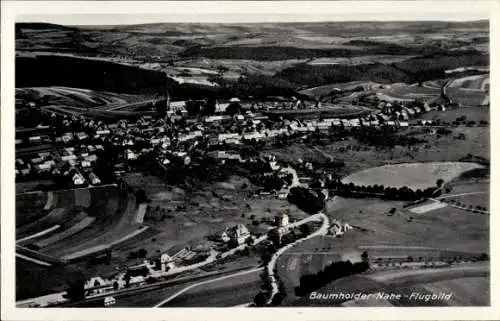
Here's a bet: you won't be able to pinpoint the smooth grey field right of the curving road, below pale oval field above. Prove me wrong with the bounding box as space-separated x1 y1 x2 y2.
320 192 489 253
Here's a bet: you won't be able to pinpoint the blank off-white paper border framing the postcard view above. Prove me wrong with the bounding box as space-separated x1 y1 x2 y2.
0 0 500 321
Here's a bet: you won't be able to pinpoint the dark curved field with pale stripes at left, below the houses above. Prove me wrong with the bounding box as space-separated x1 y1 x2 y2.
16 187 156 259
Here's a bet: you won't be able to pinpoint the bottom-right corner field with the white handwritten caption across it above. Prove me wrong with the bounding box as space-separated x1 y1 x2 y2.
287 263 490 307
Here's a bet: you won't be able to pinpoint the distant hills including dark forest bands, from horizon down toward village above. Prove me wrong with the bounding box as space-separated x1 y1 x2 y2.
16 20 489 96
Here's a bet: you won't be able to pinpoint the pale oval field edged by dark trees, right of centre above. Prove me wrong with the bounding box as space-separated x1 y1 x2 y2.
342 162 482 189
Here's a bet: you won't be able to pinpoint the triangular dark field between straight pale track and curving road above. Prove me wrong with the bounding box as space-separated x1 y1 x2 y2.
155 268 263 308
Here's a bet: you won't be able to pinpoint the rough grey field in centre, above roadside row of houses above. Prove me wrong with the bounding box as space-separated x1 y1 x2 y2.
125 173 306 253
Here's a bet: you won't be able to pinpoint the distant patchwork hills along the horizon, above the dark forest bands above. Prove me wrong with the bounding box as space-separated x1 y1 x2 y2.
16 21 488 60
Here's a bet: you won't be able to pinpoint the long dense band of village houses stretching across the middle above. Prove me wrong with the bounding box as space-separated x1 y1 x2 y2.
16 95 450 186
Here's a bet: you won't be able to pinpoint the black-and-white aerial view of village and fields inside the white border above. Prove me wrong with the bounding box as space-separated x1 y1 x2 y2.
13 6 491 311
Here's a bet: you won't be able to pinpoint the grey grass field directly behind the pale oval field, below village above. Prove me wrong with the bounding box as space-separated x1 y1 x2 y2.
265 124 490 178
